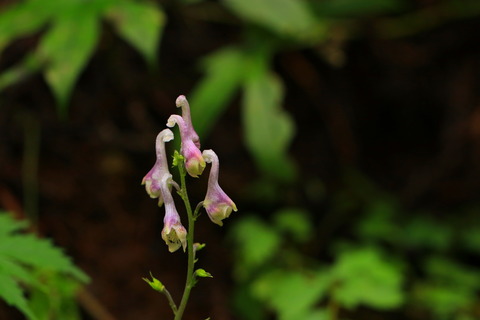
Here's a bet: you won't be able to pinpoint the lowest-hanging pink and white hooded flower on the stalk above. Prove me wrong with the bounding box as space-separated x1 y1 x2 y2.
160 174 187 252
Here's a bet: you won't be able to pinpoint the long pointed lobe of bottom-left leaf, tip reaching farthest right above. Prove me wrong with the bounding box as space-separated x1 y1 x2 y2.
0 234 88 282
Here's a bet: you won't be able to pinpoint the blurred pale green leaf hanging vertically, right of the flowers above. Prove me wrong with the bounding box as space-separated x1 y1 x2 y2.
243 53 296 181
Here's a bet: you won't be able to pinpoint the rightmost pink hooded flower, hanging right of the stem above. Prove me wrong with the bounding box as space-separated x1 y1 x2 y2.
202 150 237 226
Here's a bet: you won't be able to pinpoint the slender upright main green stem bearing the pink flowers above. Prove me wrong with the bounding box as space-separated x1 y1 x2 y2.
174 164 195 320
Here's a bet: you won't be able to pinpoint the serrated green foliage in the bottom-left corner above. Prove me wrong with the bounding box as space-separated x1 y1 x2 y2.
0 212 88 320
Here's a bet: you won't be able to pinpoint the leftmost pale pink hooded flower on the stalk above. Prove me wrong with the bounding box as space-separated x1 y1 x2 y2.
142 129 173 207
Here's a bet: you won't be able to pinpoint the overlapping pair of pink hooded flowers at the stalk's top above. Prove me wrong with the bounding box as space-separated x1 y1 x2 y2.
167 96 205 178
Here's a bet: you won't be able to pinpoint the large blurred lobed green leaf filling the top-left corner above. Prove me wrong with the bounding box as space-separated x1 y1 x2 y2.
0 0 165 115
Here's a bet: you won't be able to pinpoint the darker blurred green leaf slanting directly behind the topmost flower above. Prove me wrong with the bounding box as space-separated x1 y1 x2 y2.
189 48 246 136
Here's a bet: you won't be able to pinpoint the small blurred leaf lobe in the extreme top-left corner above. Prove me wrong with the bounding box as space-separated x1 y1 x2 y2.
0 1 51 52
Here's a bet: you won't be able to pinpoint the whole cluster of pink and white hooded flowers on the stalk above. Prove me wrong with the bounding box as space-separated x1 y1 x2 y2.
142 95 237 252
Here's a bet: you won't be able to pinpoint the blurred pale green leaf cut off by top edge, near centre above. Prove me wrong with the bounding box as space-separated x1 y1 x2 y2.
223 0 325 40
